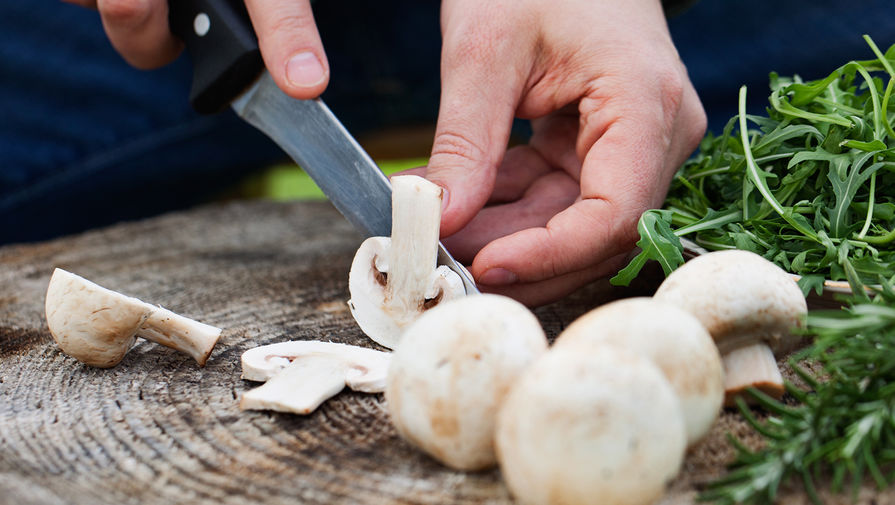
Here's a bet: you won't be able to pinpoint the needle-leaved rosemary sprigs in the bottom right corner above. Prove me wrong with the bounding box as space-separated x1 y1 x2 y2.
700 280 895 504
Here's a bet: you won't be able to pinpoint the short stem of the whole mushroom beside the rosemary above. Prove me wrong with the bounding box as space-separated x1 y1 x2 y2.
721 343 784 407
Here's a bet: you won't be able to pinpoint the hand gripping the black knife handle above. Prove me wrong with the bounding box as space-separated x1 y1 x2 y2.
64 0 329 99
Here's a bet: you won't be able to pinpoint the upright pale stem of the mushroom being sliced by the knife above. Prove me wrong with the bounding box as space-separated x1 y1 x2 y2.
385 176 444 315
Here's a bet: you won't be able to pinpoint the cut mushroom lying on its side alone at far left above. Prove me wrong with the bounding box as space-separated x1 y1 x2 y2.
45 268 221 368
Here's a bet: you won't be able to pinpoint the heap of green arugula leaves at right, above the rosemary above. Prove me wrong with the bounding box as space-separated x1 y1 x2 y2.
612 37 895 293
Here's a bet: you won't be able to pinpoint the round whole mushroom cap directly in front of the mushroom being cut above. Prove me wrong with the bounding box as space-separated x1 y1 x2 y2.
385 294 547 470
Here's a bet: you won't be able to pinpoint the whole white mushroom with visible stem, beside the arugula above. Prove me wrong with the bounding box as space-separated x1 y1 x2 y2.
655 250 808 405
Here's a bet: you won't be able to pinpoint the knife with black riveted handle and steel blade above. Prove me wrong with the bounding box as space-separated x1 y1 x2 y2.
168 0 478 294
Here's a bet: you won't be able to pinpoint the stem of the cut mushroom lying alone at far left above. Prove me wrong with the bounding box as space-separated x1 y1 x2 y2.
137 307 221 366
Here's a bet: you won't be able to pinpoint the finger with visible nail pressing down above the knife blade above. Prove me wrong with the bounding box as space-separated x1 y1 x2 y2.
246 0 329 99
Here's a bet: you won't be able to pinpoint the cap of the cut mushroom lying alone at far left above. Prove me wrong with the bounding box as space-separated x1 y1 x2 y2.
45 268 152 368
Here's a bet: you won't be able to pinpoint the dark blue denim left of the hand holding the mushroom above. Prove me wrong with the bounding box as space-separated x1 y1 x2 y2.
0 0 440 244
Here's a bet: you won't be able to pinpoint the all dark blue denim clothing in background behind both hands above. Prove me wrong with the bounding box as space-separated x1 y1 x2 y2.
0 0 895 244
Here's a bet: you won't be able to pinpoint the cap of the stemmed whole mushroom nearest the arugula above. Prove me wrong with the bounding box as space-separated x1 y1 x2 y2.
654 250 808 354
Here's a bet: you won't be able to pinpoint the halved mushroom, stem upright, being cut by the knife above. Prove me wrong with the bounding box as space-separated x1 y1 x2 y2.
348 175 466 349
